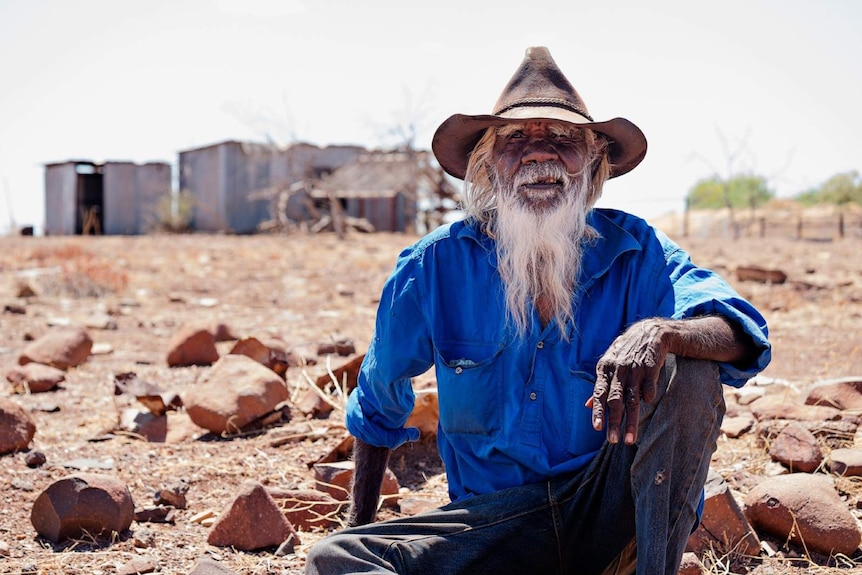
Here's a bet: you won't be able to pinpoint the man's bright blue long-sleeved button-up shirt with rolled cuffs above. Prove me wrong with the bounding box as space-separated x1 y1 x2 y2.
347 209 771 500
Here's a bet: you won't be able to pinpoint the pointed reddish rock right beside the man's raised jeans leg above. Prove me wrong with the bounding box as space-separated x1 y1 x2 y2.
685 469 760 556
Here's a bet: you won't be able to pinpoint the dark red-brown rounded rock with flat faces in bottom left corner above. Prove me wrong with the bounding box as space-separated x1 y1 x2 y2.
30 473 135 543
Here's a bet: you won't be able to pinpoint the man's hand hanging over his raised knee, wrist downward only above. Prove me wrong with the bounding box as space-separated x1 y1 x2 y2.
587 319 668 445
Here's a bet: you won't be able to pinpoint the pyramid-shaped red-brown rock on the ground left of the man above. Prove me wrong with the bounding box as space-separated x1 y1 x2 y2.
207 481 298 551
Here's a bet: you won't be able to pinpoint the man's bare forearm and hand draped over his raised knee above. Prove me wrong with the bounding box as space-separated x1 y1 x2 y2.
587 315 758 445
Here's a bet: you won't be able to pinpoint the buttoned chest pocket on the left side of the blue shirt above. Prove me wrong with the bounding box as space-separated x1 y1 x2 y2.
435 341 502 436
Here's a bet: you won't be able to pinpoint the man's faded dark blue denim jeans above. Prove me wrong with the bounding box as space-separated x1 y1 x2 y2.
306 356 724 575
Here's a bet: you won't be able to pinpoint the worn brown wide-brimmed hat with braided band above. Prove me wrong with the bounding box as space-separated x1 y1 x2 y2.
431 46 647 180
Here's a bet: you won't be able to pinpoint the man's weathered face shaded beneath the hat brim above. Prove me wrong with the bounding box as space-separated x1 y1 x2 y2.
493 120 587 211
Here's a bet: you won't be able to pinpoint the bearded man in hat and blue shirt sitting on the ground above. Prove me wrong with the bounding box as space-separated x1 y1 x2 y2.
307 48 770 575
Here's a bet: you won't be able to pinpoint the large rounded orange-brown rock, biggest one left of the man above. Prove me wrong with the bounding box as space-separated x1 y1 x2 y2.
183 355 288 433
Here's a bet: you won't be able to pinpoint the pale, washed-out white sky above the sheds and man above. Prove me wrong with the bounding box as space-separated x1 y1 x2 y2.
0 0 862 231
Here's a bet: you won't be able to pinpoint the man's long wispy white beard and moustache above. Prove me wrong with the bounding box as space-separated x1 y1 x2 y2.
494 162 592 337
